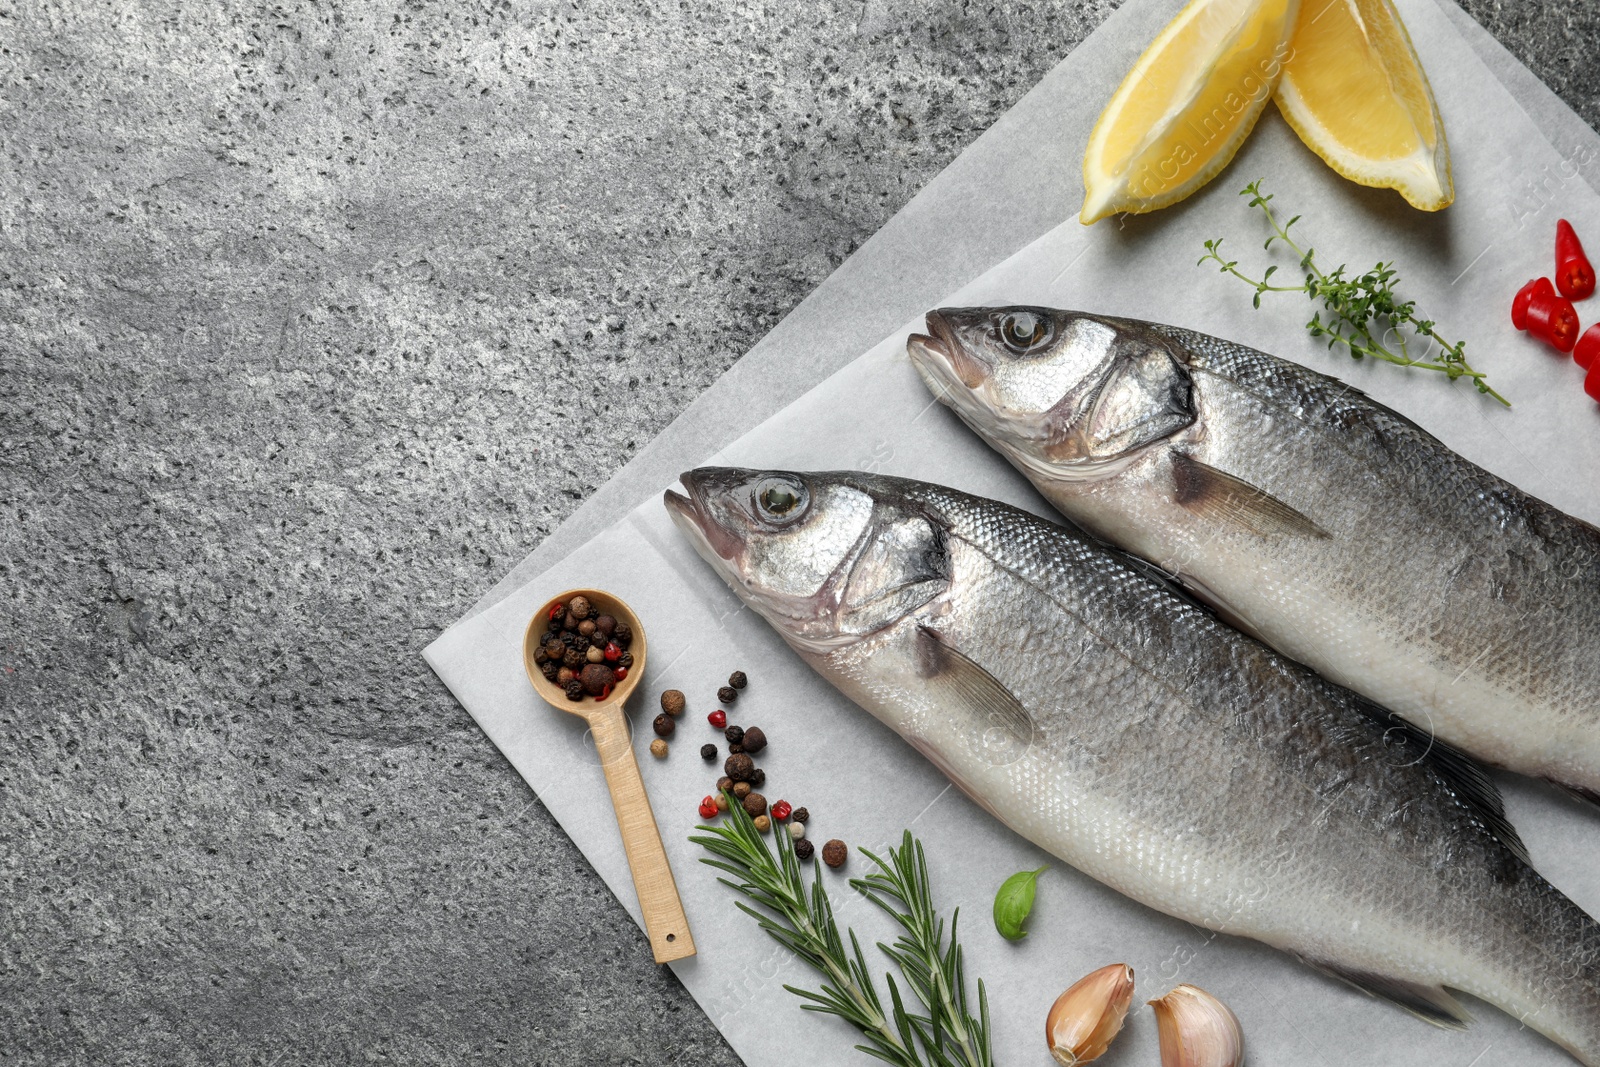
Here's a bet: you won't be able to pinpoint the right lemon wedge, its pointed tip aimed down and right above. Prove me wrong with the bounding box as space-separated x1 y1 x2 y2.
1277 0 1456 211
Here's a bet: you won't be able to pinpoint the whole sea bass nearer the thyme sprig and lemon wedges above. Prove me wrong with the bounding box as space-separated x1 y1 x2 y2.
907 307 1600 801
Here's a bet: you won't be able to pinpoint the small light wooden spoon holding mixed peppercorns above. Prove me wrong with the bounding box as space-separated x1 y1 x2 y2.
522 589 694 963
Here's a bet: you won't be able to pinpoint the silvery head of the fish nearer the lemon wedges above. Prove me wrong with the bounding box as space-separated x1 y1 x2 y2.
906 307 1195 477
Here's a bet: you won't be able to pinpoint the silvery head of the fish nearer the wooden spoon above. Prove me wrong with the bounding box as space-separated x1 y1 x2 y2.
666 467 950 654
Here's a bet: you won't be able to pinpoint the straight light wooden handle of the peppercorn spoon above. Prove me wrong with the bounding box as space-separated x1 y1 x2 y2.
589 704 694 963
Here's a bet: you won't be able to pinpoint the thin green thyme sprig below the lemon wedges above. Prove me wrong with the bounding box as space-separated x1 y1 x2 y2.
1195 179 1510 408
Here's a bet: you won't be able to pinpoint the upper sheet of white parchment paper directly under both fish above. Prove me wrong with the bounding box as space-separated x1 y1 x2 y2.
427 0 1600 1067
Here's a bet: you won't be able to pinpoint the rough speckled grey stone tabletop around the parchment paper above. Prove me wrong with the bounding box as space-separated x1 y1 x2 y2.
0 0 1600 1065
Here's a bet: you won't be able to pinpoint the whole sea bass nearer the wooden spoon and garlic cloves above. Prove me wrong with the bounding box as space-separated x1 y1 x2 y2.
666 467 1600 1067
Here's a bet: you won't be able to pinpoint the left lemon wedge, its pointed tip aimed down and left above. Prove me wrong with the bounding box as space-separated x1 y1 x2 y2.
1078 0 1305 226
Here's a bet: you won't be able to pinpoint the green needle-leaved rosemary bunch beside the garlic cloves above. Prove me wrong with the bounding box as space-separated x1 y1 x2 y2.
690 795 994 1067
